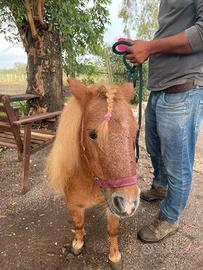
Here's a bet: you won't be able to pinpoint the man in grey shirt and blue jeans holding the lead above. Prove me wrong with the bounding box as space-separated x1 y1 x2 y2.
127 0 203 243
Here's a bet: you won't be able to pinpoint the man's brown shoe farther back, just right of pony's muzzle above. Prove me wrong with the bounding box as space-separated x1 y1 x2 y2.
140 187 166 202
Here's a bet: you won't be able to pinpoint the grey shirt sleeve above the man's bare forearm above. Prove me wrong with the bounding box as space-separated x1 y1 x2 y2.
185 0 203 52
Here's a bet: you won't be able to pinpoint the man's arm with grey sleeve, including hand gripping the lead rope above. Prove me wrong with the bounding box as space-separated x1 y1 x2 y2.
126 0 203 65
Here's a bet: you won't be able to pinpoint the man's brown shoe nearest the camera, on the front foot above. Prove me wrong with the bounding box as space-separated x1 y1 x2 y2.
138 216 178 243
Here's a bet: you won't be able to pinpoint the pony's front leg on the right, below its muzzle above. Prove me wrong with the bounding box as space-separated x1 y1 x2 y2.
107 211 122 270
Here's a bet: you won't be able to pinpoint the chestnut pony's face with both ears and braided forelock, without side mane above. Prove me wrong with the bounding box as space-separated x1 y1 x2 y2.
69 78 140 217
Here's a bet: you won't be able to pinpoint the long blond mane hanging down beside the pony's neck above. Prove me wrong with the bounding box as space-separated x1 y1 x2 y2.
46 97 82 191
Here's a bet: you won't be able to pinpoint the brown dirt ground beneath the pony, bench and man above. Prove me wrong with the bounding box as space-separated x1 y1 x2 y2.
0 124 203 270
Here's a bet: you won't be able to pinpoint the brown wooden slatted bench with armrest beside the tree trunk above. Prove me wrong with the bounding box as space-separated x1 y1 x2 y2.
0 95 61 194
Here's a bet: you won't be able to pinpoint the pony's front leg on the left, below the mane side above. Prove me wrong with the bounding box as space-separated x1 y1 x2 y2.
69 207 84 256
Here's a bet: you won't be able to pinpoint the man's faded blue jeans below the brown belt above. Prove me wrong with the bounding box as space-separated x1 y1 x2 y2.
145 87 203 223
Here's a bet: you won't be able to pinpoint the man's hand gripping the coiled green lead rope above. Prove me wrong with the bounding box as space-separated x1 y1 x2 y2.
126 40 150 66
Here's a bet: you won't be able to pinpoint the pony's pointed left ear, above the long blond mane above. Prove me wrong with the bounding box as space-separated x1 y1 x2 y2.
68 77 90 104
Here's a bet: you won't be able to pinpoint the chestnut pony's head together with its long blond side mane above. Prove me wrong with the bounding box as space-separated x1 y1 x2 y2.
47 78 140 217
